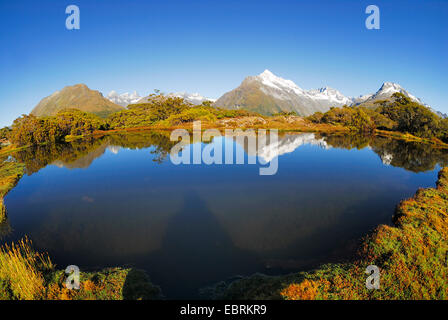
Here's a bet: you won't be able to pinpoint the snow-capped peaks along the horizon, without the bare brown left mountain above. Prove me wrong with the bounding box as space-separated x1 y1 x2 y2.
106 69 447 118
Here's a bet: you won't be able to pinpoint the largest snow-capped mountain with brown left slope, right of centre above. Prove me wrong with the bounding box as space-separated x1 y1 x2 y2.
215 70 352 116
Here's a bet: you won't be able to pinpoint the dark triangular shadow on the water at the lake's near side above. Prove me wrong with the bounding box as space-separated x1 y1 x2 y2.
140 190 262 298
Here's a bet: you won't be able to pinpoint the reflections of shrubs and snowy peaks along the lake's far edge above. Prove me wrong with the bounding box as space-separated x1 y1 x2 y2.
14 132 448 175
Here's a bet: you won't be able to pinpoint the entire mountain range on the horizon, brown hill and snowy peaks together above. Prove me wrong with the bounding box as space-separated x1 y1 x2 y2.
31 70 447 117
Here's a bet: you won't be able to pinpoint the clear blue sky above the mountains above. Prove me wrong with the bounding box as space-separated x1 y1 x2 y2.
0 0 448 126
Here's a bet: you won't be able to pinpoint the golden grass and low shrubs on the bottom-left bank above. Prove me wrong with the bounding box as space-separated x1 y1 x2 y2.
0 238 162 300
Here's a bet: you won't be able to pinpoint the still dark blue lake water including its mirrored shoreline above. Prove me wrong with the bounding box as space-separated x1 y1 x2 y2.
0 132 448 298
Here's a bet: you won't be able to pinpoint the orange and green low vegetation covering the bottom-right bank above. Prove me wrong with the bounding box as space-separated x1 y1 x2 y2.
209 168 448 300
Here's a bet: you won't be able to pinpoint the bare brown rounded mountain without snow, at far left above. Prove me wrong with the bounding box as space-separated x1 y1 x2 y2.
31 84 123 117
